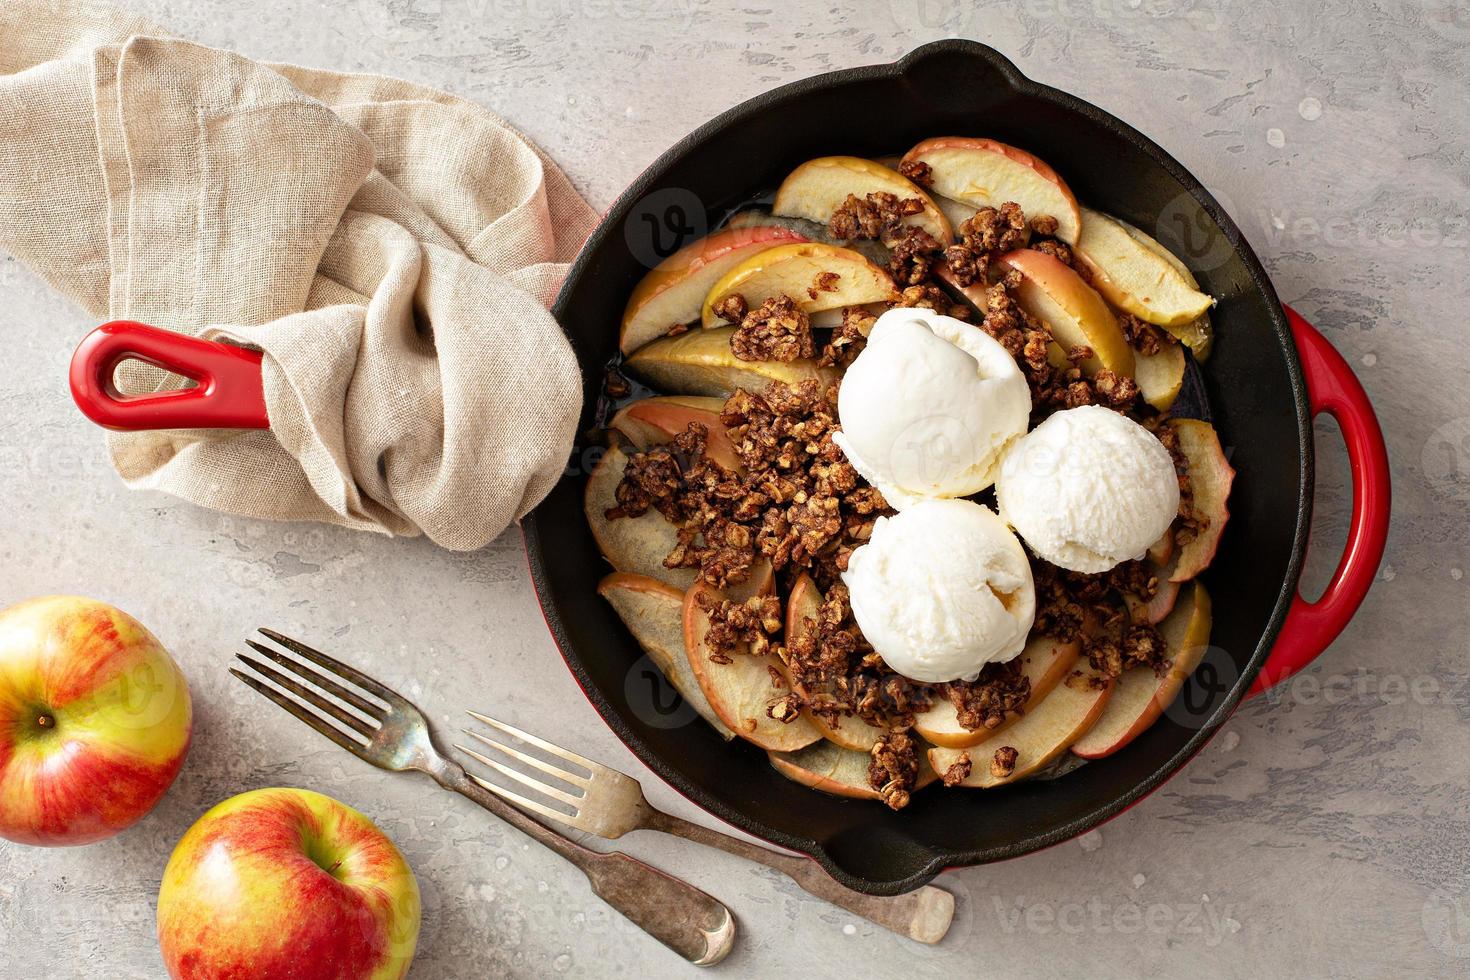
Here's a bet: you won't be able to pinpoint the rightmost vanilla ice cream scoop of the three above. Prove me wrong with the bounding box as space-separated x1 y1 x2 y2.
995 406 1179 573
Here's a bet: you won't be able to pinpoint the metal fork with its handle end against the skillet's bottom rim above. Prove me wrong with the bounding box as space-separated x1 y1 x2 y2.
454 711 954 943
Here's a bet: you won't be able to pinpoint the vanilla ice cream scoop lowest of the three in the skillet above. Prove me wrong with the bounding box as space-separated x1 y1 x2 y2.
842 500 1036 683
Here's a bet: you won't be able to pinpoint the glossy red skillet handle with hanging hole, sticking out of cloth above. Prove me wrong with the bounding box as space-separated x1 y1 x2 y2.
71 320 270 432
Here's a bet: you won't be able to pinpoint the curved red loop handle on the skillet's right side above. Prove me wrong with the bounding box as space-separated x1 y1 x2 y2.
1247 307 1391 698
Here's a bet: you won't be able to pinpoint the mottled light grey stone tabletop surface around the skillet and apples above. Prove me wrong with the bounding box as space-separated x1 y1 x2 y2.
0 0 1470 980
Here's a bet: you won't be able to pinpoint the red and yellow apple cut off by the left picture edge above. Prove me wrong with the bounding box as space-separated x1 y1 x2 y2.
0 597 194 846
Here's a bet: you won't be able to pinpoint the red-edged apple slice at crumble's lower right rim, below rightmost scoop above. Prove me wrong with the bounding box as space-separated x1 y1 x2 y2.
1072 582 1211 758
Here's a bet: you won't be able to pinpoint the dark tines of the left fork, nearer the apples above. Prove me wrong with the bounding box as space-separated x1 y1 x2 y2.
229 627 391 752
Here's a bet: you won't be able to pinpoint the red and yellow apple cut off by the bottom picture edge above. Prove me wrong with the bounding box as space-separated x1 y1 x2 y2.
159 789 419 980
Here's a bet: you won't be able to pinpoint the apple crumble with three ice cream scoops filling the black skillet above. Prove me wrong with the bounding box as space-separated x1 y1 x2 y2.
587 137 1233 810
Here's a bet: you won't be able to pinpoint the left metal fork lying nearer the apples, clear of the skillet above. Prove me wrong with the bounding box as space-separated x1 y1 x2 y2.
229 629 735 967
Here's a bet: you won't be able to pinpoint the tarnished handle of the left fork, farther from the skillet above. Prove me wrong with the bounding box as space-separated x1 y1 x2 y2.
429 764 735 967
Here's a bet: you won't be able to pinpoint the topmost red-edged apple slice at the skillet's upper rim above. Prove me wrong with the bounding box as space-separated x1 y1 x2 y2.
904 137 1082 245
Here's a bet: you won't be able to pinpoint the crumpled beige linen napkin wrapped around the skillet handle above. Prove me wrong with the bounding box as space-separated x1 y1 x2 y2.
0 0 597 550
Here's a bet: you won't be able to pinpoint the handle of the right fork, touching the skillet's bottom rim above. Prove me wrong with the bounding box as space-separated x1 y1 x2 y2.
642 808 954 943
